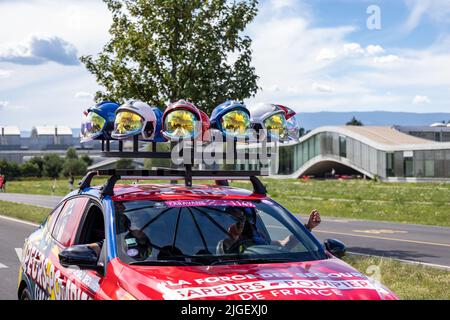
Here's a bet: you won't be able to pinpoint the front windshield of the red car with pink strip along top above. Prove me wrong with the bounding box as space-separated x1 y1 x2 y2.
114 200 326 265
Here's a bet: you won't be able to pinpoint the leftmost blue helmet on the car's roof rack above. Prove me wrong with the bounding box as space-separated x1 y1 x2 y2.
81 101 120 142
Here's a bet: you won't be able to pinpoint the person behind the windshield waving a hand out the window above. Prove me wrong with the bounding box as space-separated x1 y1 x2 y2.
216 207 321 254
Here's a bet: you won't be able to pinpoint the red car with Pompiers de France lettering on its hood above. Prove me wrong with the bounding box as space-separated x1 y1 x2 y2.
18 170 397 300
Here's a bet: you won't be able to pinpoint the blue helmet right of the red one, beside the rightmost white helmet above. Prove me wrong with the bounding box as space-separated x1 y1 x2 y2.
210 100 250 136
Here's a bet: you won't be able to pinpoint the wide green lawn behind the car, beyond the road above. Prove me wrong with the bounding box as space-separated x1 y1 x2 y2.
3 179 450 226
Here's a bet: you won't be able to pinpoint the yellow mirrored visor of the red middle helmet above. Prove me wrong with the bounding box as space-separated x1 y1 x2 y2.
164 110 198 139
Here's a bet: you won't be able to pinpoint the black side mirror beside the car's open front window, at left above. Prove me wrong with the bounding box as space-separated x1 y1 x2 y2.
58 244 99 269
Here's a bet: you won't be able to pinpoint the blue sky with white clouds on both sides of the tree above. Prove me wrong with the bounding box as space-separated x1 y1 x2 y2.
0 0 450 130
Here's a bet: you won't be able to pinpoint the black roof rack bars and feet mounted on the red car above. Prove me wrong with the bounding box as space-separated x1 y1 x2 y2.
79 165 267 196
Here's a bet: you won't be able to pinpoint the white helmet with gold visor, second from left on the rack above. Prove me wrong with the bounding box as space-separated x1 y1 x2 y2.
111 100 161 140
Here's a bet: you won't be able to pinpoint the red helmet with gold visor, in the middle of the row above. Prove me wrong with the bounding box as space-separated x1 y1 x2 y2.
162 100 209 140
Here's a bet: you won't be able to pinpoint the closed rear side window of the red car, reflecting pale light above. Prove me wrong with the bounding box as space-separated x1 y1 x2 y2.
52 198 88 247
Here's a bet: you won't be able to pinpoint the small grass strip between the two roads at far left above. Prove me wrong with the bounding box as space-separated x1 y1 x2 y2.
0 201 51 223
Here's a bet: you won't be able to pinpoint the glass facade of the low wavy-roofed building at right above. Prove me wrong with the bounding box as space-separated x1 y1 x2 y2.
272 132 450 179
